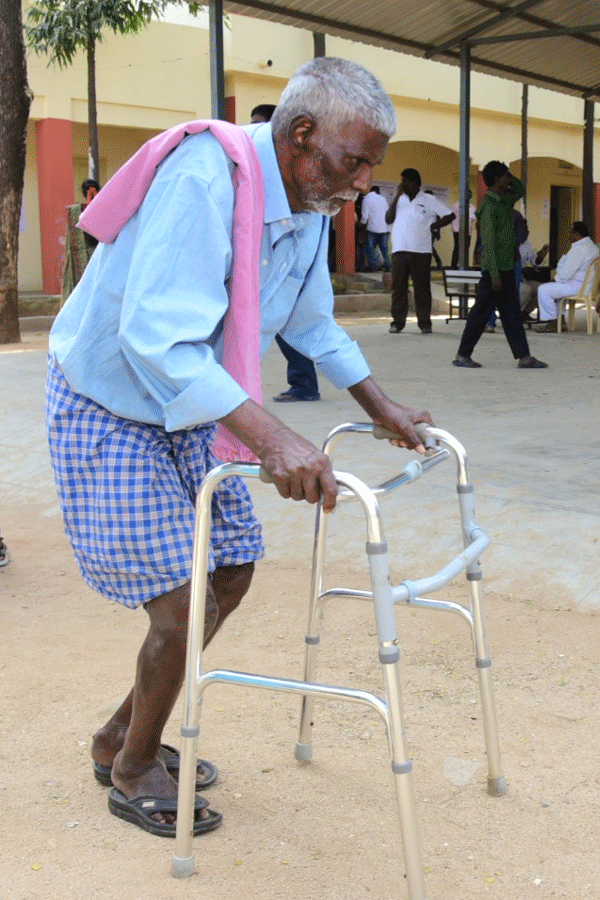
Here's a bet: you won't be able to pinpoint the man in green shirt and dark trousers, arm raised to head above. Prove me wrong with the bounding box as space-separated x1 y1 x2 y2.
452 160 547 369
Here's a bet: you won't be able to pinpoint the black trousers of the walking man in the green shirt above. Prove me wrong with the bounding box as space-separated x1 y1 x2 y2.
458 269 529 359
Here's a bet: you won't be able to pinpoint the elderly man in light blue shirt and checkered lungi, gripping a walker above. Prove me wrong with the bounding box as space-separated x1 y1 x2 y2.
47 58 431 836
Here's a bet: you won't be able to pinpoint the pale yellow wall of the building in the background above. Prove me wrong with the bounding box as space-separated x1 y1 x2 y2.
19 4 600 291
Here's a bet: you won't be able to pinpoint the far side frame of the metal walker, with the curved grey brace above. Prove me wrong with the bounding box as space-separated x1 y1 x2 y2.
295 423 507 796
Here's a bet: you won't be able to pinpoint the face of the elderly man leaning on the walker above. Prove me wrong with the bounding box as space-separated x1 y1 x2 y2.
290 119 389 216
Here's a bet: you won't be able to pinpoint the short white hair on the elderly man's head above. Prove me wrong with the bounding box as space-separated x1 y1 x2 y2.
271 56 396 137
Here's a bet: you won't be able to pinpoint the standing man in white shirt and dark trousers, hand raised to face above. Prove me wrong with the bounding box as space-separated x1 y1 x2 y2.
385 169 454 334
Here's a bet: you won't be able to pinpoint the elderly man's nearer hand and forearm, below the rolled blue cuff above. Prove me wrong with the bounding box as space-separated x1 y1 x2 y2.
220 400 337 512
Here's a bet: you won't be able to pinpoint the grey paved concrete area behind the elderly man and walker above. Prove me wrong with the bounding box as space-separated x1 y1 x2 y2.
0 317 600 610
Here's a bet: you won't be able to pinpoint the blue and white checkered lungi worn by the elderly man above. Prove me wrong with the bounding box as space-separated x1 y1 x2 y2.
46 359 264 608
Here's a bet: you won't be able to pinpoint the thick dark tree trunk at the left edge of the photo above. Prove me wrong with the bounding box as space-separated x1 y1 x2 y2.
0 0 31 344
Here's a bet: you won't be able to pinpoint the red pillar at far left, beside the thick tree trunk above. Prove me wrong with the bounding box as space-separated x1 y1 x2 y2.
35 119 74 294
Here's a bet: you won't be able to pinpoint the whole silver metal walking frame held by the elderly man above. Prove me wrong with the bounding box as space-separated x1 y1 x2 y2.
171 423 506 900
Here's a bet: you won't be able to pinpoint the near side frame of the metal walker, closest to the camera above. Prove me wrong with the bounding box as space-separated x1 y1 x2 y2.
171 463 425 900
